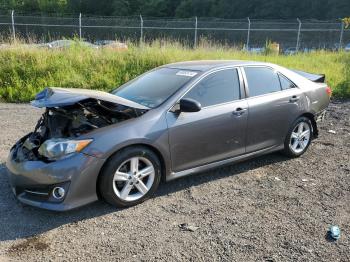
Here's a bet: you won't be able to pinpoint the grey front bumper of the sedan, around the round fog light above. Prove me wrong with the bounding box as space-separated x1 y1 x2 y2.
6 147 104 211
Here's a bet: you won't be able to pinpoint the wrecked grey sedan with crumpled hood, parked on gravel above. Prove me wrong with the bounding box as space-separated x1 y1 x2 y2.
6 61 331 211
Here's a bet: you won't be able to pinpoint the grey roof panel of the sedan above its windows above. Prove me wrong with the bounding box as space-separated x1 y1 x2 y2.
163 60 267 71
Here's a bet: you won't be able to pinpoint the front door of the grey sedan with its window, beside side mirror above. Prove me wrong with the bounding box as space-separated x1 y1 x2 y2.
167 68 248 172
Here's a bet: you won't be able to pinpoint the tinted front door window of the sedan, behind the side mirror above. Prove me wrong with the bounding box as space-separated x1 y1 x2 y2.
185 69 240 107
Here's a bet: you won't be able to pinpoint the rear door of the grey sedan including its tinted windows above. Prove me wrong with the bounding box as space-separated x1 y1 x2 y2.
244 66 302 153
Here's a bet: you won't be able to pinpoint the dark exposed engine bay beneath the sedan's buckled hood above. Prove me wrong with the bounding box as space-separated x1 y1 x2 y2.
15 98 147 161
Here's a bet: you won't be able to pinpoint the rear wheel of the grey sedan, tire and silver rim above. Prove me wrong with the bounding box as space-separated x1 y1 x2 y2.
283 117 313 157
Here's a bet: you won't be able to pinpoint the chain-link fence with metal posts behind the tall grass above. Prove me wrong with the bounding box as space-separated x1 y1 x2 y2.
0 12 350 51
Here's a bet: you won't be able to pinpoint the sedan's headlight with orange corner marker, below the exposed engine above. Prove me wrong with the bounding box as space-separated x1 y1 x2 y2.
39 138 92 159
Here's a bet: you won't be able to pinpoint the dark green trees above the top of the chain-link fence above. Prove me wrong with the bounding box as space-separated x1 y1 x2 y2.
0 0 350 20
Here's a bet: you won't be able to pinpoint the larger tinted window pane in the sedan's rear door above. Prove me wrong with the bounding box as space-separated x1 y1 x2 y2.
244 67 281 97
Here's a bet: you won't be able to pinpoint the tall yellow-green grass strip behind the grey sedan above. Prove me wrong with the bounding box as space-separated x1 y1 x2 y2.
0 41 350 102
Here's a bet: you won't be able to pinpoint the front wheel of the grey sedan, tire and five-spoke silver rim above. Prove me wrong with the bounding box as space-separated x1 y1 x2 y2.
98 146 161 207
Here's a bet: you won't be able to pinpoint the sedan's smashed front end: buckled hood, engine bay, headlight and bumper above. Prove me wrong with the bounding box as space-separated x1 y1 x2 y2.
6 88 148 211
